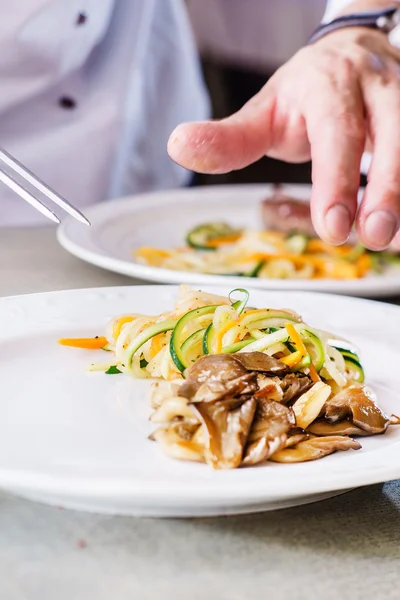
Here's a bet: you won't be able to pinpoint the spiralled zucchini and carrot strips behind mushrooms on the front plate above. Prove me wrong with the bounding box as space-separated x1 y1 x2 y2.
60 286 364 387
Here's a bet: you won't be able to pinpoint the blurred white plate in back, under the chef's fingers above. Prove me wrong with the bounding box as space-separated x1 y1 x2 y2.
58 185 400 297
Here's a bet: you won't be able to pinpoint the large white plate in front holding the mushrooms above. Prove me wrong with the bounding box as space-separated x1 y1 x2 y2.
0 286 400 516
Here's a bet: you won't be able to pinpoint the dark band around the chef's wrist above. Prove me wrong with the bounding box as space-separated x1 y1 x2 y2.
307 5 400 44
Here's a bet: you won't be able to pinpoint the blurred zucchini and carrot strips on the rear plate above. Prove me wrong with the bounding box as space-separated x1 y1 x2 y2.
135 223 400 280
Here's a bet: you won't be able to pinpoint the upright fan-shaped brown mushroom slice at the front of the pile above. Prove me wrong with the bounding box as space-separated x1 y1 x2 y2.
193 398 257 469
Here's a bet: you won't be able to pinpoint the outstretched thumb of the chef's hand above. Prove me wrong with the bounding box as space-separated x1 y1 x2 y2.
167 93 275 174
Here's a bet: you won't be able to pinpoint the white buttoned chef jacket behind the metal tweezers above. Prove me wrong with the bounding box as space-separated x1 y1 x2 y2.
0 0 209 226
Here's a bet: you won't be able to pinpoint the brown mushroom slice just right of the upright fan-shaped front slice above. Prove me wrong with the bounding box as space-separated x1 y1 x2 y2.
243 399 295 465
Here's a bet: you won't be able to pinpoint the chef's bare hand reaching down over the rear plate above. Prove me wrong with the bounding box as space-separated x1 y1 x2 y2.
168 28 400 250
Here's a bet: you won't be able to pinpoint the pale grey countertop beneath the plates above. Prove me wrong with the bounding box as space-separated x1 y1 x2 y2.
0 228 400 600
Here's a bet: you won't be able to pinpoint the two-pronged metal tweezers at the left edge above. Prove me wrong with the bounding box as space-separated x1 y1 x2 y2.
0 149 90 225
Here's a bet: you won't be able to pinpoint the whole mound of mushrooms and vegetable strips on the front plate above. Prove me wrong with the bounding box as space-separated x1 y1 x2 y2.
59 286 400 469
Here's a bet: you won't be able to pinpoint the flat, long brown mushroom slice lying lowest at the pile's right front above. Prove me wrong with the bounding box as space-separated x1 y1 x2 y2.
270 435 361 463
